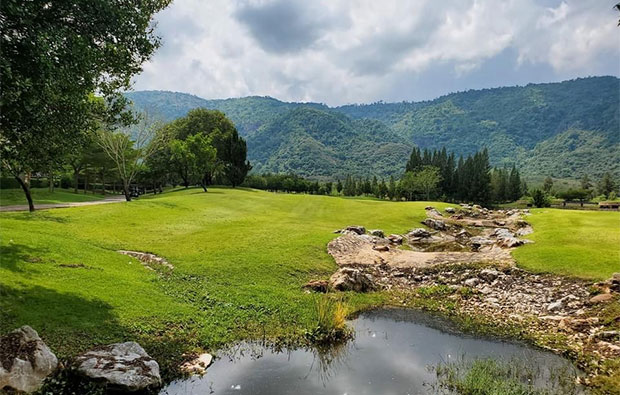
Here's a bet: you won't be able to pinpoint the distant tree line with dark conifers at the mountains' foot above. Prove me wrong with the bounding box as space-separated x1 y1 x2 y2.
244 148 527 204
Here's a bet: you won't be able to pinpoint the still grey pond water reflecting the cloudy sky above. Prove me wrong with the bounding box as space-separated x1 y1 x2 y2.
162 310 566 395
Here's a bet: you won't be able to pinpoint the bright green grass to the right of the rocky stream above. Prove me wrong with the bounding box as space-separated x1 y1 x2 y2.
513 209 620 280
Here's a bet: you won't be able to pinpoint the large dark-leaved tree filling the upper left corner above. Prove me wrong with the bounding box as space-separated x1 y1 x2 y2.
0 0 170 211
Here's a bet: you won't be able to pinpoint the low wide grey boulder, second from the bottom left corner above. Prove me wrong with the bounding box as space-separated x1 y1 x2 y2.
76 342 161 392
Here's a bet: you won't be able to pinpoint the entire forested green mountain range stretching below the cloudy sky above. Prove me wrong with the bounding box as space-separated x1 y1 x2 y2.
126 77 620 179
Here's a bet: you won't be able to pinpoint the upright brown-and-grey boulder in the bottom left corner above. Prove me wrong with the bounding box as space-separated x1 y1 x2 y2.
0 325 58 393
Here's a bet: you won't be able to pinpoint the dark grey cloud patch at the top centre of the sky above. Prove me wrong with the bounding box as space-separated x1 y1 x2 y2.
235 0 334 53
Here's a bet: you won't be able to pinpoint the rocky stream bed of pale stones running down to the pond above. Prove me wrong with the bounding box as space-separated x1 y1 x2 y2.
307 205 620 368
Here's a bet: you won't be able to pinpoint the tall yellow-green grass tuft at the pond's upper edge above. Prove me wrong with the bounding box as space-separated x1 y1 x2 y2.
306 295 352 345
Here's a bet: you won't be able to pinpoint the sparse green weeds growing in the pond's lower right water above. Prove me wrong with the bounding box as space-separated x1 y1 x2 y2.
434 359 581 395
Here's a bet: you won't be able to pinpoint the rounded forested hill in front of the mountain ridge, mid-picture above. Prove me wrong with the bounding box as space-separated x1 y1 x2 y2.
247 106 412 179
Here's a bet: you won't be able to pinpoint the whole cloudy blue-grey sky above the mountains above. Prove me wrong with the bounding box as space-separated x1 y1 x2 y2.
134 0 620 106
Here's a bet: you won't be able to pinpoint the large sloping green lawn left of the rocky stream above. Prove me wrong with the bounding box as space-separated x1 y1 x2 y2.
0 188 446 376
